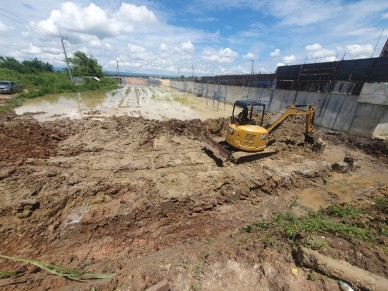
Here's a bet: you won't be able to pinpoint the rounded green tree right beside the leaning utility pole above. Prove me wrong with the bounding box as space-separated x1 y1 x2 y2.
69 51 103 77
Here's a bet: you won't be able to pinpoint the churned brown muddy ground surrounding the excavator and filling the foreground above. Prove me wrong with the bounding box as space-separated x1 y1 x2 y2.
0 78 388 290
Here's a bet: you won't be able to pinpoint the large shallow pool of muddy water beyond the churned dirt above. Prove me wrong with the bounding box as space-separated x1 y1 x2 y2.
15 85 232 121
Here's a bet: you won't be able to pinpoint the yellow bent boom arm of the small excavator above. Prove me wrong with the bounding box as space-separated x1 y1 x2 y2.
264 105 315 133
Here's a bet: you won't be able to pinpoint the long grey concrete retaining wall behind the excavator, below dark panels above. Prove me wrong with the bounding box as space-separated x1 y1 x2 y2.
171 81 388 138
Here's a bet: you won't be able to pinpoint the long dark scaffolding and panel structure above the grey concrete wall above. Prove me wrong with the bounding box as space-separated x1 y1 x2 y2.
195 56 388 100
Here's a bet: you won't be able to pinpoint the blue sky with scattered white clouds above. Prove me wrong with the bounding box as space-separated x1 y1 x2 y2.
0 0 388 76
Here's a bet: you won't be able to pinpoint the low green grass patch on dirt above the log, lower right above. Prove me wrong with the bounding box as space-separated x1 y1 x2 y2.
241 197 382 249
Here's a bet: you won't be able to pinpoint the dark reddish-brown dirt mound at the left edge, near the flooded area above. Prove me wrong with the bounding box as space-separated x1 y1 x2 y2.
0 115 65 163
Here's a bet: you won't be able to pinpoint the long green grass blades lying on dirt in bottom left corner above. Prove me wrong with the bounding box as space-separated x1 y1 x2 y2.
0 255 115 282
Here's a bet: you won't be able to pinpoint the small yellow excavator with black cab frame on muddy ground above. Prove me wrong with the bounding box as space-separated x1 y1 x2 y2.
204 100 315 161
